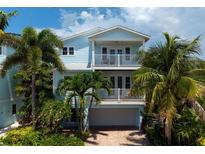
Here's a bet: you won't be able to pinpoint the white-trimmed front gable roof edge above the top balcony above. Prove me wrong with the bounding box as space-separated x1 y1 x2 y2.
88 25 150 41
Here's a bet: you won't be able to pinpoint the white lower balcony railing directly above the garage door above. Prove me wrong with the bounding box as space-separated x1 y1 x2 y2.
97 88 144 101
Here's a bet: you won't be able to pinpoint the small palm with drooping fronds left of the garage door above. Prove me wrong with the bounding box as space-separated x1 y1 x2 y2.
58 72 109 133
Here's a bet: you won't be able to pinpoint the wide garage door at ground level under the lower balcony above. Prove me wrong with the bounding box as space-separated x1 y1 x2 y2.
90 108 137 127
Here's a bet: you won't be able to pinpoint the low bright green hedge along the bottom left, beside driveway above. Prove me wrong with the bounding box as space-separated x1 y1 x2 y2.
0 127 84 146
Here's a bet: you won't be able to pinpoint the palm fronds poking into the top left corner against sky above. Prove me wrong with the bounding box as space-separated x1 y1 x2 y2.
0 10 17 32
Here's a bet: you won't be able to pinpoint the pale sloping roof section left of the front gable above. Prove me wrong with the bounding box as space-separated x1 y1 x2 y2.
62 27 104 41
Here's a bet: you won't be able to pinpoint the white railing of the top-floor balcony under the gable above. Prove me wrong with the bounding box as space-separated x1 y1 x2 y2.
95 54 139 67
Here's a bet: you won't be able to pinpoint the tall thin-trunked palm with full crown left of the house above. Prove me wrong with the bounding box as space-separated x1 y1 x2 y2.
0 27 64 129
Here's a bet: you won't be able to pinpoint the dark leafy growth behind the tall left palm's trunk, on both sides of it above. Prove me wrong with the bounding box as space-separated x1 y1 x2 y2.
14 63 54 124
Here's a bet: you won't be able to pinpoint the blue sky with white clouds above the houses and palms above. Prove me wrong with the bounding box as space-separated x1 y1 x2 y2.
0 7 205 59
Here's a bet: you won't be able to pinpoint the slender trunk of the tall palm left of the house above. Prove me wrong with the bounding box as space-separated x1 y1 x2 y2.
31 73 36 130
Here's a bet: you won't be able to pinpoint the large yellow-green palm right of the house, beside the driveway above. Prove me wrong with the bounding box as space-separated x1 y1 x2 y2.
132 33 205 144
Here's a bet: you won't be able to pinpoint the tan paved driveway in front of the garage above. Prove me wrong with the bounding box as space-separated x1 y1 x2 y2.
85 129 148 146
